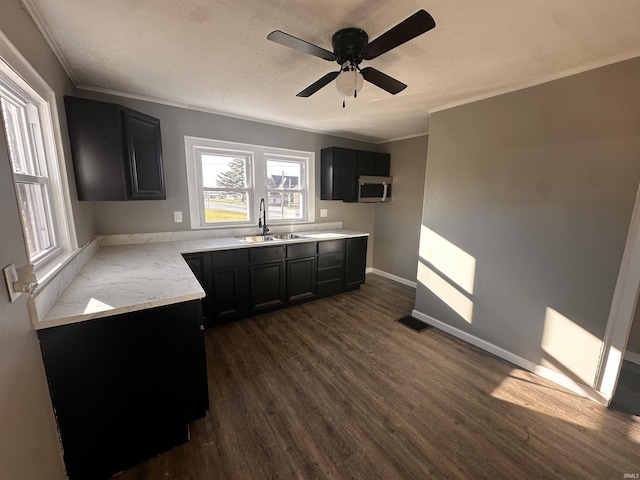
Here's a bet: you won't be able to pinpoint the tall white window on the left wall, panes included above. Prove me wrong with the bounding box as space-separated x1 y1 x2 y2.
0 53 75 276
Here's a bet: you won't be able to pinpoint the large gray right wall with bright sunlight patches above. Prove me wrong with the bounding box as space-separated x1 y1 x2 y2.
416 58 640 384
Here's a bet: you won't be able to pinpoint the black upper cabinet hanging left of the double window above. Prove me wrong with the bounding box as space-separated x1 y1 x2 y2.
65 96 166 201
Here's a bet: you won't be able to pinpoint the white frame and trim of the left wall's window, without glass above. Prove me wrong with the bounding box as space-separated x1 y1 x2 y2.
0 32 78 280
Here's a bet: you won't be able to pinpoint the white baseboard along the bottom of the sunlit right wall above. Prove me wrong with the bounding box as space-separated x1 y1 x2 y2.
411 309 611 407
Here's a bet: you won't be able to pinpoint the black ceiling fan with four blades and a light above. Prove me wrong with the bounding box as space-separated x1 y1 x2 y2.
267 10 436 101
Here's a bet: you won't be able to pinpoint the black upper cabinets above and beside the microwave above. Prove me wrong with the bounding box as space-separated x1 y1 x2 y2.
320 147 391 202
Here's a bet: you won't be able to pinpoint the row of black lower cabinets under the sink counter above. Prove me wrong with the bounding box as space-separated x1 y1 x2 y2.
183 236 367 327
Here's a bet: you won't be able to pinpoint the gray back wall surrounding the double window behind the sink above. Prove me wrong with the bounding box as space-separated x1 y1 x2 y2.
79 91 381 266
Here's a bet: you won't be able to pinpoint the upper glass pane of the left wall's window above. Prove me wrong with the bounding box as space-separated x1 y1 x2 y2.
0 97 40 175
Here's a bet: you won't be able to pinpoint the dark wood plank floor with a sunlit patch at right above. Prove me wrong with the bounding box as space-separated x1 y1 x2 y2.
117 275 640 480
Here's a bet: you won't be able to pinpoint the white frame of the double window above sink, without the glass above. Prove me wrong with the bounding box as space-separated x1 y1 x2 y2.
184 135 315 229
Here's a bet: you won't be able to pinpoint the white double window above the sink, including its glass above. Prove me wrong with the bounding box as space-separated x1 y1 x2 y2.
185 137 314 228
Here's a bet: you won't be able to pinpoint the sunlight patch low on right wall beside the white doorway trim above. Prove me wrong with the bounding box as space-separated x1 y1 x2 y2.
541 307 603 386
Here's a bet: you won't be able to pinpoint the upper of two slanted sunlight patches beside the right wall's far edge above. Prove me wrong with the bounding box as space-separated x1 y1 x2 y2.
420 225 476 294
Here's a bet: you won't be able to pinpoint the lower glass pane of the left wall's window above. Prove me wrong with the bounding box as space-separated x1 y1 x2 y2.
16 182 54 260
